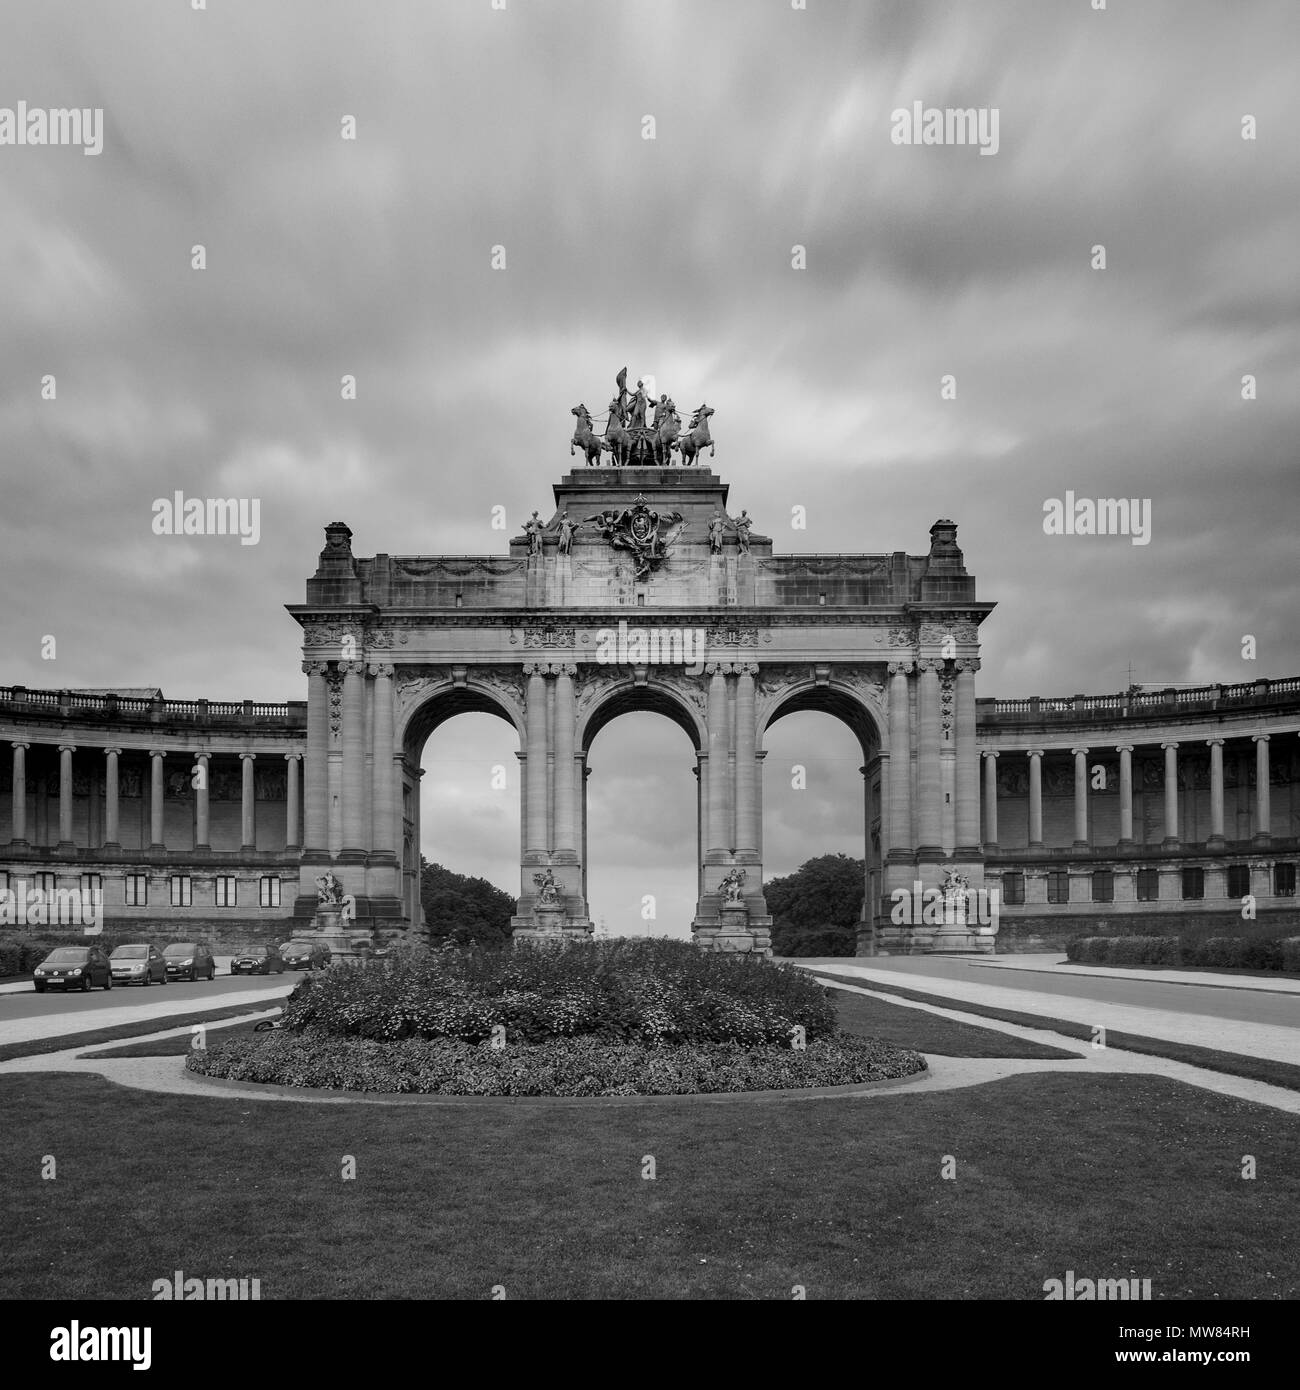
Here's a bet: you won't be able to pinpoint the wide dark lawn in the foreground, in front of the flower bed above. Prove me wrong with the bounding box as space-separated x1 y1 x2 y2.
0 1074 1300 1300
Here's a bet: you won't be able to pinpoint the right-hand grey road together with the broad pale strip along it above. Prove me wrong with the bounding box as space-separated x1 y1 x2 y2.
793 956 1300 1066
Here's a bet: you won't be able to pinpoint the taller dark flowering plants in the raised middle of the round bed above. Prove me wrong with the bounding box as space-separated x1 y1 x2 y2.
284 938 836 1047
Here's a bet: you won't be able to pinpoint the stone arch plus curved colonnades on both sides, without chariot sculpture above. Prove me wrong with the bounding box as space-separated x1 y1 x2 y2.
0 467 1300 954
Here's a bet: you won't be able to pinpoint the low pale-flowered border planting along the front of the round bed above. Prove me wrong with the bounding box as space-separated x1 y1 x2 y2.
185 1030 925 1095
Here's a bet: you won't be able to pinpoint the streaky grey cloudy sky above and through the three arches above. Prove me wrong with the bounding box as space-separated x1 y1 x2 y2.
0 0 1300 930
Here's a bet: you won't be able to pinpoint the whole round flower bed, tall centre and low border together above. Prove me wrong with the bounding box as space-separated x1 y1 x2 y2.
186 938 925 1095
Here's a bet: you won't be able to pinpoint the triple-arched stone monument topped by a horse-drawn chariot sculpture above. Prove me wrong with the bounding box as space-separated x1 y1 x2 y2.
289 373 993 954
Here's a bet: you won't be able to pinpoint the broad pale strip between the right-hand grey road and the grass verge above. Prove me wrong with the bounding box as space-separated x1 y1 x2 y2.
791 956 1300 1066
